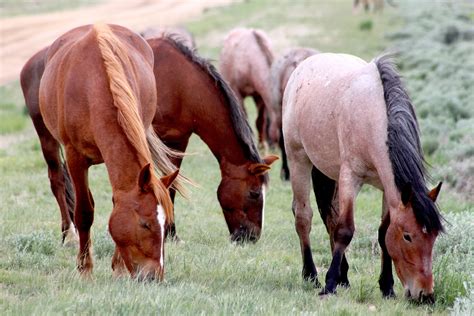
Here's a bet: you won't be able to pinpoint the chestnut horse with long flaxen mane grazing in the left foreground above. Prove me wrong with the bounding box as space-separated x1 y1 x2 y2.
21 24 185 279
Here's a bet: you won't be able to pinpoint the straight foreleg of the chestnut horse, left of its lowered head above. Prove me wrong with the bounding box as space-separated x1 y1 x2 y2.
66 146 94 277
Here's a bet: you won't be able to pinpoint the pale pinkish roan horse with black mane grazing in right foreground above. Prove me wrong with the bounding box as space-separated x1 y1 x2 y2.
283 54 443 303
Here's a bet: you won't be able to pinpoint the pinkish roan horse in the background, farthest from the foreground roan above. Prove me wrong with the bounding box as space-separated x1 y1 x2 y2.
219 28 274 147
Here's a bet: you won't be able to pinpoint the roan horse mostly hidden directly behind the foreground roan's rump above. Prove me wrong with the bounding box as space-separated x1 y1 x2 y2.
270 47 319 180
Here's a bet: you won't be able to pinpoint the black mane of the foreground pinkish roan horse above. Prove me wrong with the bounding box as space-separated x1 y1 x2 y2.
374 55 444 232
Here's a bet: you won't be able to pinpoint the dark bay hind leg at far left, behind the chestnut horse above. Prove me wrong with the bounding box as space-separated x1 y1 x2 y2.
32 115 78 245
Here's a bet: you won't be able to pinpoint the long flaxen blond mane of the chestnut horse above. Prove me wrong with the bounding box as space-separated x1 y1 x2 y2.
94 24 173 221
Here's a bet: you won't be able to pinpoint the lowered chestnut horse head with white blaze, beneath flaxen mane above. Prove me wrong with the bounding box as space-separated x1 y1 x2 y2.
109 164 178 280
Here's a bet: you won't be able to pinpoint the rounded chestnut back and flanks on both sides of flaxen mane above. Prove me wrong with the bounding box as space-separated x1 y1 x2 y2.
39 25 156 163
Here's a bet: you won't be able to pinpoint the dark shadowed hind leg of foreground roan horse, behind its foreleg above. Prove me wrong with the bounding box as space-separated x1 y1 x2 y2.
311 166 350 287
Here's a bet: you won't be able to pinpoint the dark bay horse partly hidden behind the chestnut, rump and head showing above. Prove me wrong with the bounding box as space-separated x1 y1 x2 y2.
21 34 277 242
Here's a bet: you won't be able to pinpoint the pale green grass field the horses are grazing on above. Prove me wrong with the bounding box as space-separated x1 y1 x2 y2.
0 0 474 315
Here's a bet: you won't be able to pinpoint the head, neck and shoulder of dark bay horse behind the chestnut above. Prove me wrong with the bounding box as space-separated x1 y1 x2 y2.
148 38 277 241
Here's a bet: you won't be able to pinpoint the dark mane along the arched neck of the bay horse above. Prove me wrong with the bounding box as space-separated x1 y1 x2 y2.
159 35 262 167
